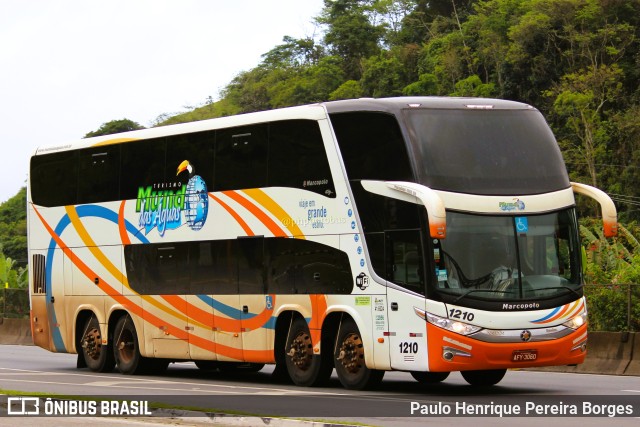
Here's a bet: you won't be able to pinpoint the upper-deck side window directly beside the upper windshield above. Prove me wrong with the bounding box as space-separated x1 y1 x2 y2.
331 112 414 181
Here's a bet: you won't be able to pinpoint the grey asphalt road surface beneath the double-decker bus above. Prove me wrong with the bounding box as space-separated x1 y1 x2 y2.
0 345 640 427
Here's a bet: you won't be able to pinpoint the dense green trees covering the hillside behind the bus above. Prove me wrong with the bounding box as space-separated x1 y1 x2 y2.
0 0 640 326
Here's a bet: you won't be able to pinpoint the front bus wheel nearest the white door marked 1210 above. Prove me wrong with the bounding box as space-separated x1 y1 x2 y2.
334 319 385 390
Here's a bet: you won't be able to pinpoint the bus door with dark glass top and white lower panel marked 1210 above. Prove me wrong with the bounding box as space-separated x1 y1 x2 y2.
385 230 428 371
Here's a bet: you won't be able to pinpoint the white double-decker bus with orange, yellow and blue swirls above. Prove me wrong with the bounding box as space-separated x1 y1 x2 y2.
28 97 617 389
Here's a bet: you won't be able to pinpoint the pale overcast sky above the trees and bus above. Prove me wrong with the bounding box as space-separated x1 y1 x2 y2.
0 0 323 203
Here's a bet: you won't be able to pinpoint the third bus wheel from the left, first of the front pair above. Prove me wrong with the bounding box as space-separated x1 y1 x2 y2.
285 316 333 387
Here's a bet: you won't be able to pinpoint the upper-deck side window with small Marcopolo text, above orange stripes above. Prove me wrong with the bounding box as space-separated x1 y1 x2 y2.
269 120 335 197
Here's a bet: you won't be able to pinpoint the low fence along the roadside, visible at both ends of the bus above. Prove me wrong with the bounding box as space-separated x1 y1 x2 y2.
0 284 640 332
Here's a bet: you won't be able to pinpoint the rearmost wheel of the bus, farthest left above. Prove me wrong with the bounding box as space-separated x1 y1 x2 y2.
75 310 115 372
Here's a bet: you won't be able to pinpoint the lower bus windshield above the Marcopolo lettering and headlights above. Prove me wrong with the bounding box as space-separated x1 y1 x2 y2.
434 209 582 306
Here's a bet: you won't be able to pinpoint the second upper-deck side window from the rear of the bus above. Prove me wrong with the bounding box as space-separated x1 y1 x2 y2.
77 145 120 204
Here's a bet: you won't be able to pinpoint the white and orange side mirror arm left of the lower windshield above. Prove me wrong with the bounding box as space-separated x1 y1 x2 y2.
360 180 447 239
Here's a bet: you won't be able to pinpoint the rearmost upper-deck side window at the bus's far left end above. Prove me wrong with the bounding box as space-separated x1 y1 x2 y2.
29 151 78 206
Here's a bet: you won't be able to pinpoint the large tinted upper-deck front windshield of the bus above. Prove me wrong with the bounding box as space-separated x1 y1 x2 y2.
405 108 570 195
